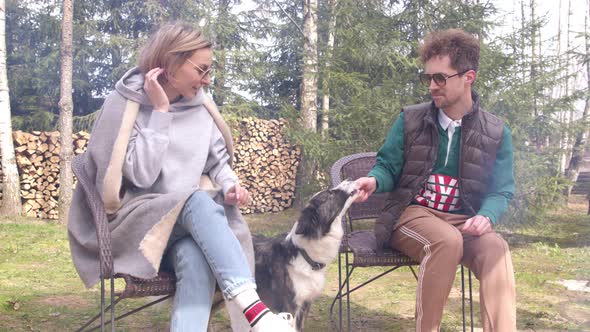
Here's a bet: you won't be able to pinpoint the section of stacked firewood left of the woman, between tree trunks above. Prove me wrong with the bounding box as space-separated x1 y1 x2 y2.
13 131 90 219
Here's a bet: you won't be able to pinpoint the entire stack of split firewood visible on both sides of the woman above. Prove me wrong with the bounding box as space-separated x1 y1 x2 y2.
13 118 300 219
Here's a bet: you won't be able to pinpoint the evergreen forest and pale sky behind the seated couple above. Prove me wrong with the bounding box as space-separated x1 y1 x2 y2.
5 0 590 223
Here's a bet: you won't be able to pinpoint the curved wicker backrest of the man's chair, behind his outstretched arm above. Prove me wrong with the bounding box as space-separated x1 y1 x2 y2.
330 152 387 220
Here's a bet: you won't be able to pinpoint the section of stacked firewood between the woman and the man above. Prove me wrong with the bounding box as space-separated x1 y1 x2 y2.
235 118 300 213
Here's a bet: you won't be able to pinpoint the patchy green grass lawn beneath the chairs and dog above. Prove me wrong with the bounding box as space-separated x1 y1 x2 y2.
0 198 590 331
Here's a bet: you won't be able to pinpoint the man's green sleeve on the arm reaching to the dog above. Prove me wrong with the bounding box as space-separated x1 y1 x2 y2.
368 112 404 192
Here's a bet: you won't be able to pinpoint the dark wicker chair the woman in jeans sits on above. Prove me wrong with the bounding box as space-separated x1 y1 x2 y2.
72 154 176 331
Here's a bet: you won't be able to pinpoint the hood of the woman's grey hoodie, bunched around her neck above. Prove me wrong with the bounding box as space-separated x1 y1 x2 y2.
115 67 205 112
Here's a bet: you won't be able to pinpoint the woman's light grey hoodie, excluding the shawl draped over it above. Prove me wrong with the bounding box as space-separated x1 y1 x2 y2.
116 69 237 203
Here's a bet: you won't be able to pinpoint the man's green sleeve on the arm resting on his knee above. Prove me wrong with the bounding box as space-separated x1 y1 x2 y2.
477 126 514 224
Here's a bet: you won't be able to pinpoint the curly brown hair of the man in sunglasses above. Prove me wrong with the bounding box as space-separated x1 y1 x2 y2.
419 29 479 72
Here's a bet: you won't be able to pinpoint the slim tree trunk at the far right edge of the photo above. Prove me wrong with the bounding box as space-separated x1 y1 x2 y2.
565 2 590 197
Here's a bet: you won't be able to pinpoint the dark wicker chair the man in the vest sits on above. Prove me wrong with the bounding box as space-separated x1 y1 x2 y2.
330 152 473 331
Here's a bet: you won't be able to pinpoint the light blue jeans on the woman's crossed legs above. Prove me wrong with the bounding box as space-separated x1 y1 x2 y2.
163 191 256 331
